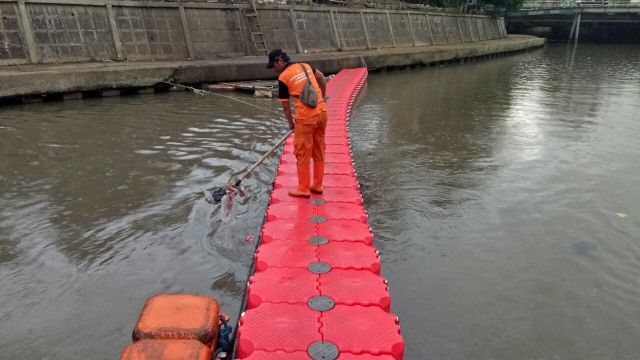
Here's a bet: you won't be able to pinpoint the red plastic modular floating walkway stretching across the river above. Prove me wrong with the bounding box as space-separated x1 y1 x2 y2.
236 68 404 360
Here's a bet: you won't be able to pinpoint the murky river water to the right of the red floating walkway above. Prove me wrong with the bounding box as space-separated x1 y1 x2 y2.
350 45 640 360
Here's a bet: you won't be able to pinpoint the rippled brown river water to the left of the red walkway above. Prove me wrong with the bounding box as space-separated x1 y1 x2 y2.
0 93 286 359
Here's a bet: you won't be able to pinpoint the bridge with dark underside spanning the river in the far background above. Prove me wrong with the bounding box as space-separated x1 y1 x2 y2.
505 0 640 43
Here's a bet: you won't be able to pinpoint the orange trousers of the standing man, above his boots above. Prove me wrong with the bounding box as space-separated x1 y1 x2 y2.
293 111 327 165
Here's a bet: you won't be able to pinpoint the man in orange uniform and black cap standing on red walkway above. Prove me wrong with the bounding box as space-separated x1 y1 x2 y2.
267 49 327 197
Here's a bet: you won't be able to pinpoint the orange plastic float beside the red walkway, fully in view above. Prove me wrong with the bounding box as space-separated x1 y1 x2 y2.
132 294 220 348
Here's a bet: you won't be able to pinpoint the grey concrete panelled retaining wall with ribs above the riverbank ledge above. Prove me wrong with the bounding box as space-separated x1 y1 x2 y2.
0 0 507 65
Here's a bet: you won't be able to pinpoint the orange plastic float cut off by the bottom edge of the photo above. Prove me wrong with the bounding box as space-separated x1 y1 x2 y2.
120 339 211 360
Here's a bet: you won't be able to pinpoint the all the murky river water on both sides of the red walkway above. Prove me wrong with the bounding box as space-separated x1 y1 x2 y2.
0 44 640 360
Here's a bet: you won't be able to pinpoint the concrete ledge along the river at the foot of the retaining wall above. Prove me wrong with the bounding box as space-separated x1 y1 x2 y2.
0 35 545 103
